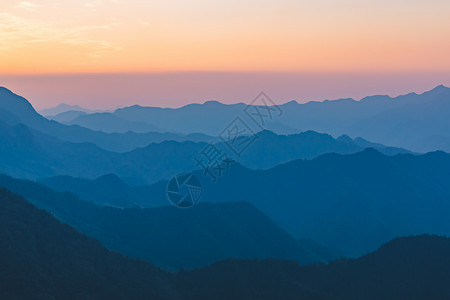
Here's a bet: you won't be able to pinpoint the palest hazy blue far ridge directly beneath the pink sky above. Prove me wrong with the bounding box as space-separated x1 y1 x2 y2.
62 85 450 152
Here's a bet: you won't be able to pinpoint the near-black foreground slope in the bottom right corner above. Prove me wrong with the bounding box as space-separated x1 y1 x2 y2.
177 235 450 300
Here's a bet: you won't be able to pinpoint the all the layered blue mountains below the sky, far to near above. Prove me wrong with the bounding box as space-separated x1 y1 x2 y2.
0 86 450 300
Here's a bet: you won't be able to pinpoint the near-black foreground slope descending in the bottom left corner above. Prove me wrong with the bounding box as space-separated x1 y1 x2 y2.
0 188 178 299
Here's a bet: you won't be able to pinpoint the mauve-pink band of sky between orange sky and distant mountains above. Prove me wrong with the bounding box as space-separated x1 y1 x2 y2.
0 72 450 109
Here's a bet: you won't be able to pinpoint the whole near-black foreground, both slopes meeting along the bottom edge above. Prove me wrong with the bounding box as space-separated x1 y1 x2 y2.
0 189 450 300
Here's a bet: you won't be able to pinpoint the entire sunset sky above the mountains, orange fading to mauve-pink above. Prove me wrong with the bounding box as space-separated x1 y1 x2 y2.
0 0 450 107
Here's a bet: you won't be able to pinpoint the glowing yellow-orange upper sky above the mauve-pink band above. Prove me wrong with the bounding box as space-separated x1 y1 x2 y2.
0 0 450 74
